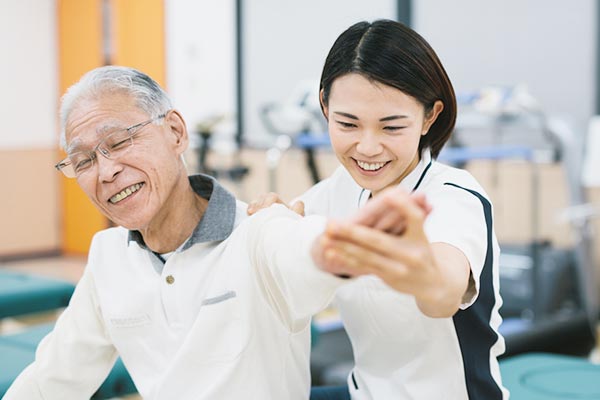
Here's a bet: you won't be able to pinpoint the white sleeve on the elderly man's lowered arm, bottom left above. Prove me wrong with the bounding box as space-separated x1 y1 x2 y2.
4 268 117 400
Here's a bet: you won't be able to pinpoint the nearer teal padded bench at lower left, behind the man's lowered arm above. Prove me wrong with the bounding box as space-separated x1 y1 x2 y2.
0 324 137 399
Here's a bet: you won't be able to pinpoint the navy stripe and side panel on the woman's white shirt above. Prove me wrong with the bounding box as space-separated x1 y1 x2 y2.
445 182 502 400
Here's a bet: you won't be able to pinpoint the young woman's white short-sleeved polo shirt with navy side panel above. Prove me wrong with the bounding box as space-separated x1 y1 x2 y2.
301 151 508 400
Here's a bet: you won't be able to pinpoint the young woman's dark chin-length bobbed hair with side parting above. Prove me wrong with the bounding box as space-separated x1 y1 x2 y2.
320 20 456 158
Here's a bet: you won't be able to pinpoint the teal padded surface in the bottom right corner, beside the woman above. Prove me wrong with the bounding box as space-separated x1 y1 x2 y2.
500 353 600 400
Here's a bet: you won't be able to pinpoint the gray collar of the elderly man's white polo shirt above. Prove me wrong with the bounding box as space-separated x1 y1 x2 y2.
128 174 236 250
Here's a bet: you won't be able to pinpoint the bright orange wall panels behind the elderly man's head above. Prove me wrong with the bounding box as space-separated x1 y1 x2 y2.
57 0 165 254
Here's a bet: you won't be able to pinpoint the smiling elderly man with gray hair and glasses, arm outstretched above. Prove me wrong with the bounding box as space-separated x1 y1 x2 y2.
5 66 414 400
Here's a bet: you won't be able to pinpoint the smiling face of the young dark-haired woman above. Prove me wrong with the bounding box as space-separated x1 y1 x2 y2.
324 73 443 195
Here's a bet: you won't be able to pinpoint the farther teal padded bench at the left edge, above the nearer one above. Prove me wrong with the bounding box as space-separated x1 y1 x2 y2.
0 270 75 319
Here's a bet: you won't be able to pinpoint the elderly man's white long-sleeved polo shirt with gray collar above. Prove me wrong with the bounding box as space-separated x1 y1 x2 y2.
5 176 343 400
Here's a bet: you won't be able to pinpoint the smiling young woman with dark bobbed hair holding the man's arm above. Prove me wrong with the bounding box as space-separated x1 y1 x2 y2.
250 20 508 400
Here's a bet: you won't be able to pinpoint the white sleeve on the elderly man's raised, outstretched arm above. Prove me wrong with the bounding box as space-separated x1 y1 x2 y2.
246 205 347 331
